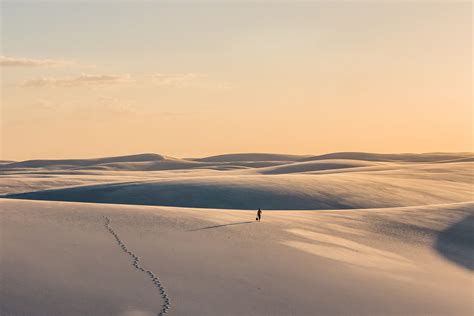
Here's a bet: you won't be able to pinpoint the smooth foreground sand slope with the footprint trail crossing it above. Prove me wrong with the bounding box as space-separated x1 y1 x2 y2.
0 200 474 315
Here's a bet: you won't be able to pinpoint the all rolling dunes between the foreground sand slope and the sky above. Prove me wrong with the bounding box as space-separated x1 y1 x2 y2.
0 152 474 210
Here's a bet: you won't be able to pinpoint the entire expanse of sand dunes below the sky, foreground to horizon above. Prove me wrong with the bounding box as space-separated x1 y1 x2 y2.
0 153 474 316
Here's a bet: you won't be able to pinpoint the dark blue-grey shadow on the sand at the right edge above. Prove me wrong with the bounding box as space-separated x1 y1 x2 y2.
435 214 474 271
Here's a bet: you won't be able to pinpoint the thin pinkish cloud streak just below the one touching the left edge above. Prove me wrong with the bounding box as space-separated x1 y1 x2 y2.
22 74 133 87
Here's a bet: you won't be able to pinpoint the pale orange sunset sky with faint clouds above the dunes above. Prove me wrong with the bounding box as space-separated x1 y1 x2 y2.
0 0 474 160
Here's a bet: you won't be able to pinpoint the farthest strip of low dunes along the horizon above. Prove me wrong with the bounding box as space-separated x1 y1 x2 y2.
0 152 474 172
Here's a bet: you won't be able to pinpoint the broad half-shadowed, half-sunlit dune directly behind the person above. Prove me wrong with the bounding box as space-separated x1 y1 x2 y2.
7 174 472 210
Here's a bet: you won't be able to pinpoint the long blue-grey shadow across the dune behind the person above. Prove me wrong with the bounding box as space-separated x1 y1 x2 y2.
0 178 353 210
